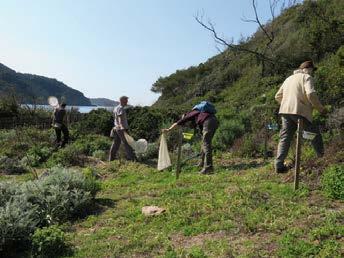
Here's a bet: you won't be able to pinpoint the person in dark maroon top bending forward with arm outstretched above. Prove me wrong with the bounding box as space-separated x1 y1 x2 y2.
162 109 218 174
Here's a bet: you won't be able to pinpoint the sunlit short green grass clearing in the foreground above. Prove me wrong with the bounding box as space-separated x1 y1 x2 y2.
62 156 344 257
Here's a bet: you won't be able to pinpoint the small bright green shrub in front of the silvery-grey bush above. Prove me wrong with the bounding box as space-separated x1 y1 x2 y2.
32 225 68 257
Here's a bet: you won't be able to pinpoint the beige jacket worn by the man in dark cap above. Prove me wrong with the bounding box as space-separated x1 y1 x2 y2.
275 70 324 122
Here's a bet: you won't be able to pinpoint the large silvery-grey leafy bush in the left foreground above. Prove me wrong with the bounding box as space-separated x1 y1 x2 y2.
0 168 100 254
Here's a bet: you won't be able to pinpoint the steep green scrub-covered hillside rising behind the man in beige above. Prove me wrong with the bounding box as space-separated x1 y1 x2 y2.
152 0 344 110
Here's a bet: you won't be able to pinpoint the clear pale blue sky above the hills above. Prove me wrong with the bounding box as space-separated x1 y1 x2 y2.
0 0 284 105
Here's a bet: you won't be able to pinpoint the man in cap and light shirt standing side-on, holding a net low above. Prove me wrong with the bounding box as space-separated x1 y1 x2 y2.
109 96 136 161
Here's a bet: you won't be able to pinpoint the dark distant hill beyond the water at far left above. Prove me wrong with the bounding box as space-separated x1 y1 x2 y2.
0 63 91 106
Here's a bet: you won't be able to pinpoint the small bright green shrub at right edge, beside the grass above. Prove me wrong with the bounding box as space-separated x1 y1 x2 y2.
321 164 344 200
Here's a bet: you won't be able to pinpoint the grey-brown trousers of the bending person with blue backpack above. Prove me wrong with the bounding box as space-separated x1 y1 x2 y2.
201 116 218 170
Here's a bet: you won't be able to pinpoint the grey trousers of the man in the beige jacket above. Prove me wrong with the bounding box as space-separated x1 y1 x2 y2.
275 114 324 168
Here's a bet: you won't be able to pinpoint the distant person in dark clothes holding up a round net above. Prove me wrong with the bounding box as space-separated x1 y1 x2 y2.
53 103 69 148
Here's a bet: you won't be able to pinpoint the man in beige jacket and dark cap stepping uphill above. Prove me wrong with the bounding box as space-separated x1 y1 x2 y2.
275 61 326 173
